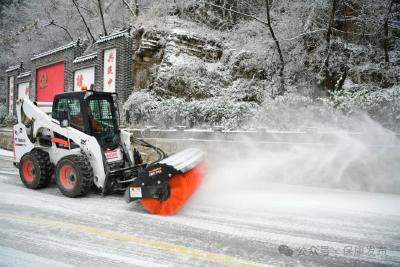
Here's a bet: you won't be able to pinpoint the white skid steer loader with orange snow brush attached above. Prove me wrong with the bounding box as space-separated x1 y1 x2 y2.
14 91 204 215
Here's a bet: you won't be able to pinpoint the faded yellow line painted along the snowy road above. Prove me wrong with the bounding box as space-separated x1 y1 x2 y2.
0 213 263 266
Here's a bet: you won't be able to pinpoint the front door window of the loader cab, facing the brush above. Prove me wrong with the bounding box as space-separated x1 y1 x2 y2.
88 97 119 151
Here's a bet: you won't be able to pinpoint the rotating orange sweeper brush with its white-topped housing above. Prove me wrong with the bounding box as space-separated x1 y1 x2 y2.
126 149 206 215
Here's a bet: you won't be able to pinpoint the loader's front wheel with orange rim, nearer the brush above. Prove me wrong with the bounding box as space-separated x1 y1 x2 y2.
55 155 94 197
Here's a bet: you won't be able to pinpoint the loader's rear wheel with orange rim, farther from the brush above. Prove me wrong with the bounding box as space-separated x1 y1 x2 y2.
19 149 54 189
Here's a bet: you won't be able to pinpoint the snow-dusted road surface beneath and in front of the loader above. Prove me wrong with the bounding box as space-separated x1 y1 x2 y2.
0 151 400 266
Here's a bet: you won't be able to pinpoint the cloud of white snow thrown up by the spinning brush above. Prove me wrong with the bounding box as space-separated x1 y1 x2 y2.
189 96 400 211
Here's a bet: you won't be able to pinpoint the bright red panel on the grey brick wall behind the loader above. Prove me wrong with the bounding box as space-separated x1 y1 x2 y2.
36 62 64 102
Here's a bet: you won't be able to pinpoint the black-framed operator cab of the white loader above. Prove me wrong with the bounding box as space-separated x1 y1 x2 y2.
52 91 120 149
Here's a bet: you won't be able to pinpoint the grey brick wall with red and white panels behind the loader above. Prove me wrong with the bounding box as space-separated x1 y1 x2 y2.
5 29 134 117
